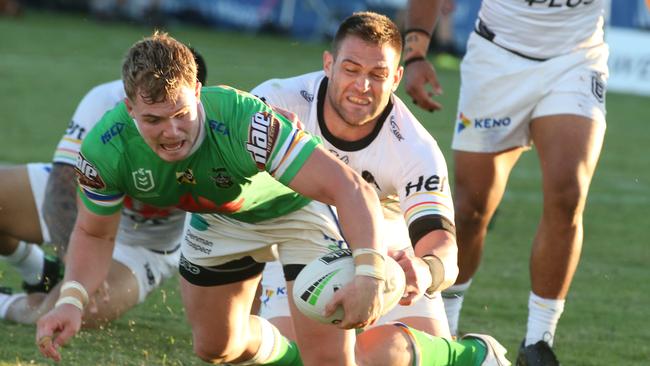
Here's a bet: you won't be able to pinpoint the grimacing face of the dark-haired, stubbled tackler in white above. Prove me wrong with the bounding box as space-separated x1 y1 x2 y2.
323 36 403 127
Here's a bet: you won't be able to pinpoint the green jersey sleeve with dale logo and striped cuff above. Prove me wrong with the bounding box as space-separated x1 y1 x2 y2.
216 86 319 185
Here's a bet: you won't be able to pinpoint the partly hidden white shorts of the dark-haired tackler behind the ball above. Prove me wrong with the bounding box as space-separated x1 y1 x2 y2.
259 261 447 325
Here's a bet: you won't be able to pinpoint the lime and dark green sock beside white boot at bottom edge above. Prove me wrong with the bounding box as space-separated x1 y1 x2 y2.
393 323 487 366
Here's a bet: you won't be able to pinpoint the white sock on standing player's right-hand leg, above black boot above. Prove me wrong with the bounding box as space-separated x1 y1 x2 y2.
525 291 565 346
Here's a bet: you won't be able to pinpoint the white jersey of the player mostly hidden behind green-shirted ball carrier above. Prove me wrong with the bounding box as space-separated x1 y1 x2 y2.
53 80 185 252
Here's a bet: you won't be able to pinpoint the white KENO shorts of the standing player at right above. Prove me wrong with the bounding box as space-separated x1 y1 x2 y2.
452 33 609 152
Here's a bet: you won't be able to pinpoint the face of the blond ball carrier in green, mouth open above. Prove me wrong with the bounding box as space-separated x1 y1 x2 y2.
126 82 201 162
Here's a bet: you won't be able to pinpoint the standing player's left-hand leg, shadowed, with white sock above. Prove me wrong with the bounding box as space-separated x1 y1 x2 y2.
443 148 523 336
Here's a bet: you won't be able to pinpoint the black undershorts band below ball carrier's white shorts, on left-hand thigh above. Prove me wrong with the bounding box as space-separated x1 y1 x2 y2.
178 253 264 287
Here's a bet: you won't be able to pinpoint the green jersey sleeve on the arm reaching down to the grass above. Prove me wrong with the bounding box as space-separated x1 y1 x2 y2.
75 105 125 215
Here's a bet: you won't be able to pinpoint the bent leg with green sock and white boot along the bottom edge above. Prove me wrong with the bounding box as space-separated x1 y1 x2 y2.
355 323 510 366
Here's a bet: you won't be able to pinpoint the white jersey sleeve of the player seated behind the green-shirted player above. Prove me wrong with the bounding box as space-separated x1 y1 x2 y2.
52 80 123 166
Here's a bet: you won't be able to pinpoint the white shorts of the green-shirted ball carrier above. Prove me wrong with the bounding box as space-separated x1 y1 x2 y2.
181 201 347 267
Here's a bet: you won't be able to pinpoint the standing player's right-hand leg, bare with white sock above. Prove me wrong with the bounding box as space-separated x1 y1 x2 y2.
525 115 605 345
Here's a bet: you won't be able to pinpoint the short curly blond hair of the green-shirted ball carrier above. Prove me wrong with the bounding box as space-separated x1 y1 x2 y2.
122 31 197 104
